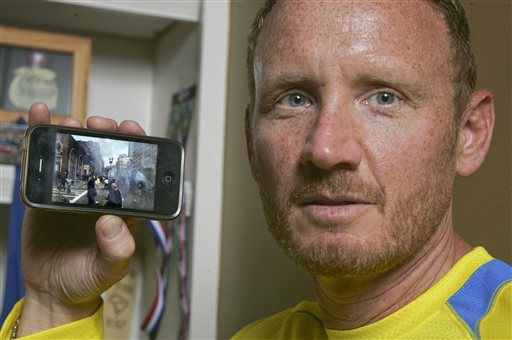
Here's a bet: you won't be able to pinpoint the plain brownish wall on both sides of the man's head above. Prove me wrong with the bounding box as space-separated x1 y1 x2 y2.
218 1 512 338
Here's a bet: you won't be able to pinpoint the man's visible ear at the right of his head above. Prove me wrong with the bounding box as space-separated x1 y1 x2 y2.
456 90 494 176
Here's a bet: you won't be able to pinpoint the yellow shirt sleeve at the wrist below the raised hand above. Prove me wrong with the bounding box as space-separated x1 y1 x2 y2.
0 299 104 340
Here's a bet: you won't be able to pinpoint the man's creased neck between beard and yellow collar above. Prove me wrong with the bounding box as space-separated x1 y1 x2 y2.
314 220 471 330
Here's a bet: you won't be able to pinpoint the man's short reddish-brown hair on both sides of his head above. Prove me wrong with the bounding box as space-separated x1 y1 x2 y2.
247 0 476 114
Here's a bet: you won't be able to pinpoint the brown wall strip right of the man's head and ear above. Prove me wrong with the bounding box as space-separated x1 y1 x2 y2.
454 1 512 263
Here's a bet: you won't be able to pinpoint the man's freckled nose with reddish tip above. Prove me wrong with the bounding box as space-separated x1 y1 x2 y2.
301 110 363 170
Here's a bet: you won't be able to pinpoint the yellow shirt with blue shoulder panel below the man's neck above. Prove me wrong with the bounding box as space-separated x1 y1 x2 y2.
234 248 512 339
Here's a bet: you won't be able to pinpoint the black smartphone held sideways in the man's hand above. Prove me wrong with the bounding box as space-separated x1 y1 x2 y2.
20 125 184 220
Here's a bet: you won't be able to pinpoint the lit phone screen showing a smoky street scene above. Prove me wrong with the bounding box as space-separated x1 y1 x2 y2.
52 133 158 211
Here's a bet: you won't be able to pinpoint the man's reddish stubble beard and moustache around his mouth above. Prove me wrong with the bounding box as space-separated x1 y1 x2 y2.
260 132 455 277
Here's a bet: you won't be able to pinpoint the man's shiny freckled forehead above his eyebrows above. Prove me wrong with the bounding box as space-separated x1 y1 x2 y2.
253 0 451 86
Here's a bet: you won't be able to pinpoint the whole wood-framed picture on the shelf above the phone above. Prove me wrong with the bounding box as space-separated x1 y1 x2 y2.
0 25 91 123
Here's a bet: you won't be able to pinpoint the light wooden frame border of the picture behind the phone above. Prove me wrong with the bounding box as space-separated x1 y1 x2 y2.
0 25 91 123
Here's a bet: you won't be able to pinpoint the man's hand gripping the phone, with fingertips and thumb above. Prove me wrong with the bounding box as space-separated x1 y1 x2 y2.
18 103 144 336
